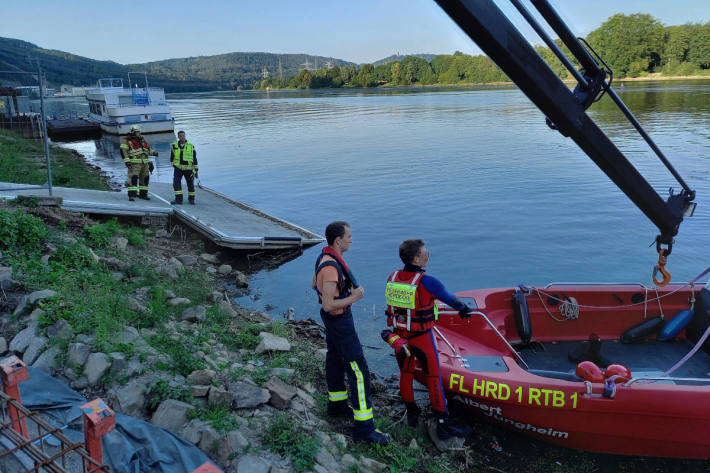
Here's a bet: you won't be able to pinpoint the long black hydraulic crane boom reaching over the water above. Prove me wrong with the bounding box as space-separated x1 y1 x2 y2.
436 0 695 258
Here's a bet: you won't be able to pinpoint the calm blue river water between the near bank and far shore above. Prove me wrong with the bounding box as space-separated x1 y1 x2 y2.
57 81 710 372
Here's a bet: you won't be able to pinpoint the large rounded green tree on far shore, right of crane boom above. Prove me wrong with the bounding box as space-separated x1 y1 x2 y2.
587 13 665 77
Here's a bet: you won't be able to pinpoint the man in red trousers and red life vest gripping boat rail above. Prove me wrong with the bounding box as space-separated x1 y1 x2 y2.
381 239 472 440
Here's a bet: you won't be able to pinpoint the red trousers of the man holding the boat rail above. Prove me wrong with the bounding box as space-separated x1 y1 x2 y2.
395 330 448 416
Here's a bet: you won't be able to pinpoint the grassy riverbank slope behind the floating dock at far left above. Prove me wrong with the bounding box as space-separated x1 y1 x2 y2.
0 129 109 190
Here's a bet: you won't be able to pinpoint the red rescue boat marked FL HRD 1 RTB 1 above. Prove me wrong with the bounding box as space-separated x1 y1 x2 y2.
426 283 710 458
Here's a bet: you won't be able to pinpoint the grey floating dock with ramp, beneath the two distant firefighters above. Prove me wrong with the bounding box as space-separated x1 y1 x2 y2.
0 182 325 250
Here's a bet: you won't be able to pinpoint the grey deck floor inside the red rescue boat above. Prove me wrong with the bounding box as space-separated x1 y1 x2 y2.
519 339 710 378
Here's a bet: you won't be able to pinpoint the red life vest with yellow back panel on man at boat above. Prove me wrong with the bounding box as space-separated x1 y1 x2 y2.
385 270 439 332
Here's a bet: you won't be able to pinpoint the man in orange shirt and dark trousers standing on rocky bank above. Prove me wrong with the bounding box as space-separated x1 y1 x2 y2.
312 221 390 445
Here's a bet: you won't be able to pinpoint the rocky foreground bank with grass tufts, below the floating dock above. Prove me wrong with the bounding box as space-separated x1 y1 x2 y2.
0 203 472 473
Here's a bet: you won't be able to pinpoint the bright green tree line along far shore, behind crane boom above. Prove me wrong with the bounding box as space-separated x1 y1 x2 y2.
253 13 710 89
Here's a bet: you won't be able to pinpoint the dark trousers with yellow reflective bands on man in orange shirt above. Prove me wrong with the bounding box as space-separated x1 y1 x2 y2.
320 308 375 434
